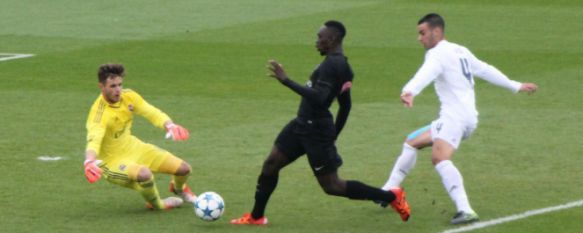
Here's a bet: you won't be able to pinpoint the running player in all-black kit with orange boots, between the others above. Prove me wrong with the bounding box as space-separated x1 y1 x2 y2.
231 21 410 225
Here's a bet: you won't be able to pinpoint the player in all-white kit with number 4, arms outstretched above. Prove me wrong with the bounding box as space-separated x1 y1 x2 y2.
381 13 538 224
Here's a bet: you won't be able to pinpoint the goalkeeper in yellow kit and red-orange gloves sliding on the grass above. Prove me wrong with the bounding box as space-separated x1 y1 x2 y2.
84 64 196 209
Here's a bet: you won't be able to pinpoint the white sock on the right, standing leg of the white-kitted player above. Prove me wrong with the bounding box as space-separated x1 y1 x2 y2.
435 160 475 213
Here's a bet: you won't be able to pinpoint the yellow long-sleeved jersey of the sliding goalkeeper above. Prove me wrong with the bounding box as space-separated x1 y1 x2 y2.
86 89 170 160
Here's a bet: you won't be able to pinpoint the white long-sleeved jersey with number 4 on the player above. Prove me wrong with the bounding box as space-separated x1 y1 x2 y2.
403 40 522 124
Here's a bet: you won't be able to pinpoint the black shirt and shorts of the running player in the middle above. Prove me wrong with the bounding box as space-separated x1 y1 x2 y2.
275 53 354 173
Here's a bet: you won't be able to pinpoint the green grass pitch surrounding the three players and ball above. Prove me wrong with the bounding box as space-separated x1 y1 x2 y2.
0 0 583 233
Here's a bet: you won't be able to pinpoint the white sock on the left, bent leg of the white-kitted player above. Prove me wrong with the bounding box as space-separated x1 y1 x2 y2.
382 143 417 190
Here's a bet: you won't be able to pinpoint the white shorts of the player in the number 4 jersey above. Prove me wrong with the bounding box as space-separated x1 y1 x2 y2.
431 117 477 149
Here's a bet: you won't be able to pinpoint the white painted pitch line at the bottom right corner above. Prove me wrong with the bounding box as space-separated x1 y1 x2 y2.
443 200 583 233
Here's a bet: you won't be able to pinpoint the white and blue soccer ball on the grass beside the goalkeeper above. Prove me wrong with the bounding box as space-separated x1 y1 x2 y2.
194 192 225 221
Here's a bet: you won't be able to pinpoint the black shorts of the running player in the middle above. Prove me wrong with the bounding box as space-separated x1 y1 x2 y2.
275 118 342 176
